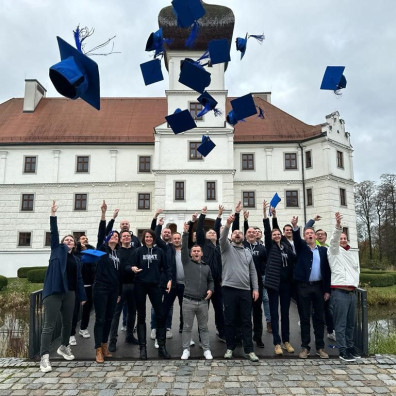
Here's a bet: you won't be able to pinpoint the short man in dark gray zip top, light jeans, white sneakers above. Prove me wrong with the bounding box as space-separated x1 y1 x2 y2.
181 223 214 360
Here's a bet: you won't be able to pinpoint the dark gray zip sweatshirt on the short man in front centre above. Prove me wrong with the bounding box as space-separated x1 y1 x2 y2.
182 232 214 299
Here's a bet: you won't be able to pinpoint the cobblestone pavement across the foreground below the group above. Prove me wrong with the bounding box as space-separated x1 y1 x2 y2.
0 356 396 396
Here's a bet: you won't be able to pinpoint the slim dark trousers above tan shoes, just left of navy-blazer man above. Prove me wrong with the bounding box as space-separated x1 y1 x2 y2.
267 282 291 345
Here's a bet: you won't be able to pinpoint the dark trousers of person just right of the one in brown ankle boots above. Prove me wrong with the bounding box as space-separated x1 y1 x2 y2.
110 283 136 342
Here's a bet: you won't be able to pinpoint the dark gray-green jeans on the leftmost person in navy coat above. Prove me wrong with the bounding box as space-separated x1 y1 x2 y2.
40 290 75 356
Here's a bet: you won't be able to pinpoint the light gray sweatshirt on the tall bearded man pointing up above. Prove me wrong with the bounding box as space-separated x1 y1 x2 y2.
220 225 258 291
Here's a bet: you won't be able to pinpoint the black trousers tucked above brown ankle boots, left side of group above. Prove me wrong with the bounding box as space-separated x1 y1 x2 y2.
93 285 118 349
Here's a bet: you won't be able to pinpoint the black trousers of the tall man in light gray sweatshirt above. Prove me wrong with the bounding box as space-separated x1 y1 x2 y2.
223 286 253 353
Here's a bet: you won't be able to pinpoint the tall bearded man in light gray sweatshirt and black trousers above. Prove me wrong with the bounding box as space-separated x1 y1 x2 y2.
220 215 259 362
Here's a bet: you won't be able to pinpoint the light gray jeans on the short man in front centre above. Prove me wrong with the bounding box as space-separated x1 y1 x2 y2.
182 297 210 351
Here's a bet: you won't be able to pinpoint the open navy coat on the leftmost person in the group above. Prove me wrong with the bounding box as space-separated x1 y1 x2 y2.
43 216 87 301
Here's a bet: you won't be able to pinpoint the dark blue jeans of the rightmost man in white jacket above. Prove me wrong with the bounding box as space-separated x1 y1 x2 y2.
330 289 356 352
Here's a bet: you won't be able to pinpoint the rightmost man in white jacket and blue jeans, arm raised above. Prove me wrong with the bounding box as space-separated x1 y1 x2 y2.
327 212 360 362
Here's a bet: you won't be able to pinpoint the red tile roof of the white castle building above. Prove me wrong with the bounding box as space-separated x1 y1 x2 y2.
0 97 321 144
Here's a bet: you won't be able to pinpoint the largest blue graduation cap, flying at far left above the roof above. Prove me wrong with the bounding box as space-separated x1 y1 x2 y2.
49 37 100 110
